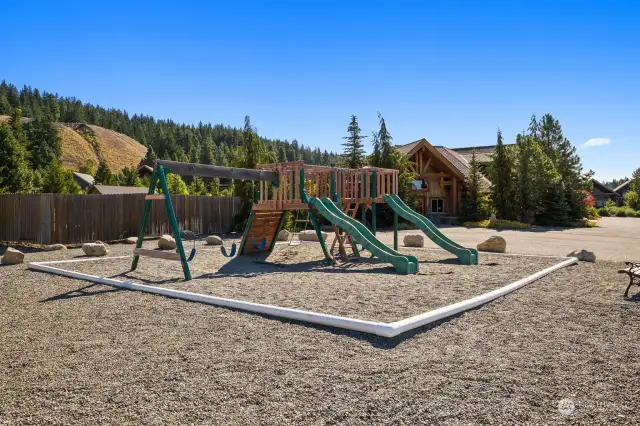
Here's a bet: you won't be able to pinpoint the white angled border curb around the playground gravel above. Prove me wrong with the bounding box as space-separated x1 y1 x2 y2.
28 256 578 337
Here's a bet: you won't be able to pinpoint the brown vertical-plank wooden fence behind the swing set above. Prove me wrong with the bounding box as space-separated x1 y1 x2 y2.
0 194 242 244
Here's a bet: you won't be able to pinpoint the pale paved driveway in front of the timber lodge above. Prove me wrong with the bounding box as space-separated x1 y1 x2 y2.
379 217 640 262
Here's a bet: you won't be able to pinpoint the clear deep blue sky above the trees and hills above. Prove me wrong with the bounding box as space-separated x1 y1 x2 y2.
0 0 640 180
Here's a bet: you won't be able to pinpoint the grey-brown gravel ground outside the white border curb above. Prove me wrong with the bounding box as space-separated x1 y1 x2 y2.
0 241 640 425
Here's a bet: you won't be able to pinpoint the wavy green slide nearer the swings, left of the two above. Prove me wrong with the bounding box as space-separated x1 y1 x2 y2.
309 197 418 275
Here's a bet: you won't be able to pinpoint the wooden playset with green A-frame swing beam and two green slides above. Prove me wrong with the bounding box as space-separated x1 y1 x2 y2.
131 160 477 280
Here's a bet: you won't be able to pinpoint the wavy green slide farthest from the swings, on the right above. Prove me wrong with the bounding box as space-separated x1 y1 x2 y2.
384 194 478 265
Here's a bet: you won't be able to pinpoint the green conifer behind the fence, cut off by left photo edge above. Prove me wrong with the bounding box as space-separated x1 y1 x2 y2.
0 124 31 193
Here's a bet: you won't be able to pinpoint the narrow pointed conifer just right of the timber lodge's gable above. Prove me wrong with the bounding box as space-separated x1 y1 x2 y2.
489 130 515 219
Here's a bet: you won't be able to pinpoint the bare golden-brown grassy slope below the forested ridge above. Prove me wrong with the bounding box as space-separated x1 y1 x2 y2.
0 116 147 172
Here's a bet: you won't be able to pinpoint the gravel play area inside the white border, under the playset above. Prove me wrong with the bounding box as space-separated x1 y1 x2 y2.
57 242 560 322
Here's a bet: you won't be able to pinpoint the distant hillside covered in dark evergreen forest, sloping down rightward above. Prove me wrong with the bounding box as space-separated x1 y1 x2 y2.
0 80 338 171
